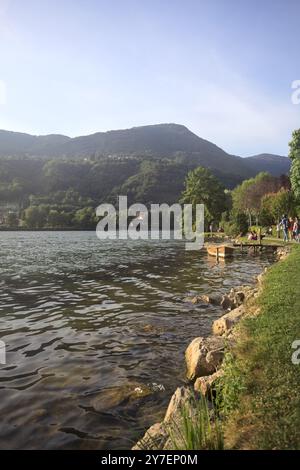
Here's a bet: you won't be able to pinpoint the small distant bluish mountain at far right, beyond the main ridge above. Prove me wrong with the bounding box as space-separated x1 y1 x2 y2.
245 153 291 176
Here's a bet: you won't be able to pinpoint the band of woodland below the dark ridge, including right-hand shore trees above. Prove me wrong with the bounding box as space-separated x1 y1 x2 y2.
0 158 290 231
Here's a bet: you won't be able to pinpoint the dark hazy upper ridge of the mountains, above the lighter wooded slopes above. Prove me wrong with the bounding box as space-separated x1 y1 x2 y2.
0 124 289 187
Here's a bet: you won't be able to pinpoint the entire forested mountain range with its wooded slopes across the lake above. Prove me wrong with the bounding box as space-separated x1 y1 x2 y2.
0 124 289 227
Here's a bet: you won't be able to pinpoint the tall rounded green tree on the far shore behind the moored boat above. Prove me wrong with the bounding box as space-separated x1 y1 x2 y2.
180 166 227 222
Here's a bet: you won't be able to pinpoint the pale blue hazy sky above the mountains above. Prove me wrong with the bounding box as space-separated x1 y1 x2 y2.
0 0 300 156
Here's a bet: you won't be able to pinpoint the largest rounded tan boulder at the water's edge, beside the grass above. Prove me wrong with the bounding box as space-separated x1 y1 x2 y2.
185 336 224 381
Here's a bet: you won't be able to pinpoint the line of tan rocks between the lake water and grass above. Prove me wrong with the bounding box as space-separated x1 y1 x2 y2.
132 247 289 450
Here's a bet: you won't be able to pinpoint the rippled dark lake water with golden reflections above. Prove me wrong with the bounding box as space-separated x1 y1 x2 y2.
0 232 272 449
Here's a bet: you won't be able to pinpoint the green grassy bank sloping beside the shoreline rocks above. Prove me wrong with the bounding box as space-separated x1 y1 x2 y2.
221 246 300 449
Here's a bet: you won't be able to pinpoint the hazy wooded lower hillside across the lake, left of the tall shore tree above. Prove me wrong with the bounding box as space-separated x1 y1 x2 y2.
0 157 204 228
